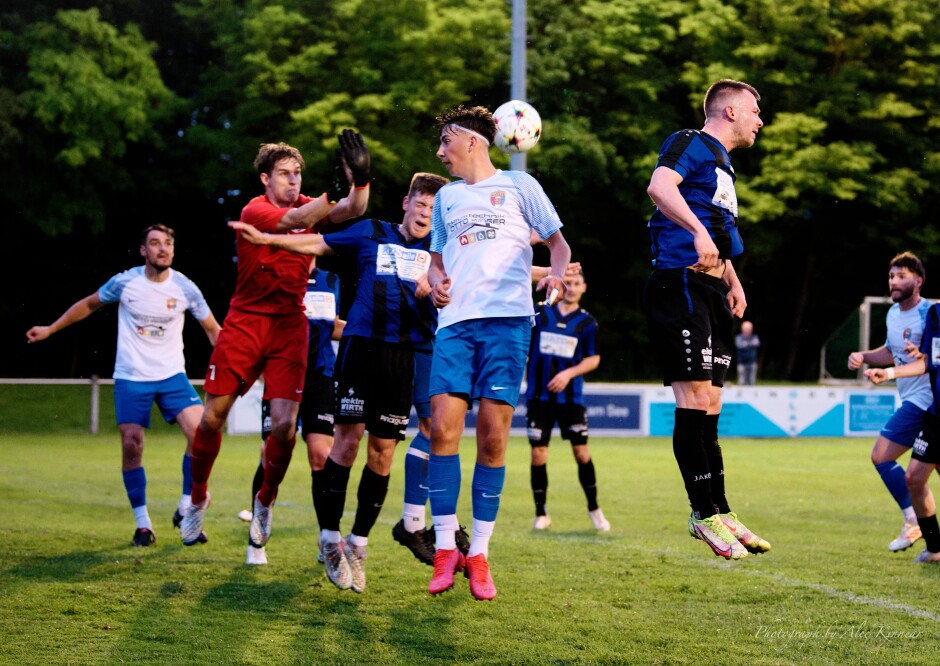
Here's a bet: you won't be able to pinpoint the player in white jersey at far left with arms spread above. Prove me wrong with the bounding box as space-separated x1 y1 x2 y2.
26 224 220 546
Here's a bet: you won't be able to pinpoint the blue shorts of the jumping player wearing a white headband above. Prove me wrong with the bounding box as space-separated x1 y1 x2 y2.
429 317 532 407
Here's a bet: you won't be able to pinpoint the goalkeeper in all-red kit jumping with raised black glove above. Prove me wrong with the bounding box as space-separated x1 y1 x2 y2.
180 129 370 547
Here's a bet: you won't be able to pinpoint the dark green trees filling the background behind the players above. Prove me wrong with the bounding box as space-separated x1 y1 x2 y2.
0 0 940 381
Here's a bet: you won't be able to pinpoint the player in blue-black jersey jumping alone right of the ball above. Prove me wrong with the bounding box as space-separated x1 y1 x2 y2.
643 79 770 559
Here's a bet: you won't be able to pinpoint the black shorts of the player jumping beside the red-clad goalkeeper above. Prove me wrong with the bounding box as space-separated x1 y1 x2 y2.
333 336 415 441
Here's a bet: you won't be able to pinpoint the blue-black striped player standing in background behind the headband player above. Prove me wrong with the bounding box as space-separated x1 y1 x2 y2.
526 270 610 532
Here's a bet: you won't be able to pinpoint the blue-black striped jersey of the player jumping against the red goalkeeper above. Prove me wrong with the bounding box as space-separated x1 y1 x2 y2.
323 220 437 348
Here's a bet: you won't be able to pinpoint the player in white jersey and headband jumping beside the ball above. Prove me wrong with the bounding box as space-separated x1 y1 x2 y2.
428 101 571 599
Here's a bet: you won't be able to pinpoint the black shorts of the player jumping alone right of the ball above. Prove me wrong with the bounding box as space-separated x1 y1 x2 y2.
643 268 734 386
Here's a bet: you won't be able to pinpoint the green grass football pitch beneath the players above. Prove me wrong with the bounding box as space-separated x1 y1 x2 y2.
0 387 940 664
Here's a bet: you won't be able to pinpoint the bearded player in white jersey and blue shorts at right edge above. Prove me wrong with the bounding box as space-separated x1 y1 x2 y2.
848 252 933 551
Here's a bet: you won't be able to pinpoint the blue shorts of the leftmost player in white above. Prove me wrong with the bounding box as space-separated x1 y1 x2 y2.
114 372 202 428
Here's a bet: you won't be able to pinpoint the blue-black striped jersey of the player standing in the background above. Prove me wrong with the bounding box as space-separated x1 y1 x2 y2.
526 303 600 405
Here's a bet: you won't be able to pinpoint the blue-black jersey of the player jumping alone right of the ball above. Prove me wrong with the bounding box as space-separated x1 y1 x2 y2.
648 130 744 269
